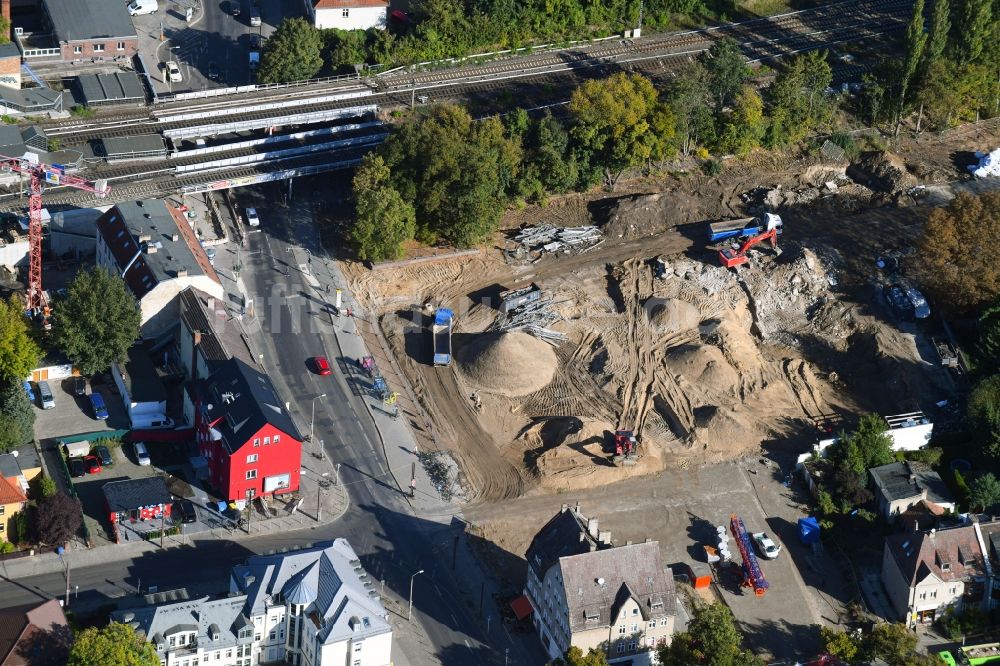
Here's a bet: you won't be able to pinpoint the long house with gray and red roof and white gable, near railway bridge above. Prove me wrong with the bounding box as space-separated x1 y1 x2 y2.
97 199 225 339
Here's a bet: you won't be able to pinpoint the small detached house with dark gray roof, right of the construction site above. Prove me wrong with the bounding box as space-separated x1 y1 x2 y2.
868 461 956 523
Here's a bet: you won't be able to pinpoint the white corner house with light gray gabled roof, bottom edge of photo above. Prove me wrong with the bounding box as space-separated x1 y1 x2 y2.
229 539 392 666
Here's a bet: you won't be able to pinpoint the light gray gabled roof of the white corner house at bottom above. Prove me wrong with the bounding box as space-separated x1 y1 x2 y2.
233 539 392 645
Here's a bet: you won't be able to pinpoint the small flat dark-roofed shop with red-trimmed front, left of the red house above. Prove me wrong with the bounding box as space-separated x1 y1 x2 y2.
101 476 173 543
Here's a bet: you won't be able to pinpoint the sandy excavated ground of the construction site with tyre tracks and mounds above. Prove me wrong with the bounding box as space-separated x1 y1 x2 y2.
346 120 997 501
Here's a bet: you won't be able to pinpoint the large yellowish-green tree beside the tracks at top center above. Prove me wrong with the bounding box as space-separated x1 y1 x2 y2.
569 72 663 188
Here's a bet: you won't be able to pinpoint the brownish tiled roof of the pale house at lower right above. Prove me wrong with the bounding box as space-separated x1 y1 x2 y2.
886 525 986 587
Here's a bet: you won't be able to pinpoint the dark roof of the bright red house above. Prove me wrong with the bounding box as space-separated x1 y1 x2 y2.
202 358 302 454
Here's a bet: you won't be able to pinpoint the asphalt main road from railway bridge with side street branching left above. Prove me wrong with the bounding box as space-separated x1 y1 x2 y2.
0 186 536 664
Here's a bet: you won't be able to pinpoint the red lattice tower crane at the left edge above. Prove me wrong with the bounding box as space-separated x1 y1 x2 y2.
0 158 111 330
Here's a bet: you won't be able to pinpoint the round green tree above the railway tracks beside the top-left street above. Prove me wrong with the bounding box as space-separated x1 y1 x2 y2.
257 17 323 83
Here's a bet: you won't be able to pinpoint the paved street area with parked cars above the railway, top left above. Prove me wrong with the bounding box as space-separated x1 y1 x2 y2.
132 0 304 94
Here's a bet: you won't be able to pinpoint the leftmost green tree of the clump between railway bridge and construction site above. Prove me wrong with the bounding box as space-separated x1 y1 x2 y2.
350 153 417 261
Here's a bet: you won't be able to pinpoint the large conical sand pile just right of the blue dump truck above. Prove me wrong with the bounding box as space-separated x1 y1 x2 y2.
455 331 558 397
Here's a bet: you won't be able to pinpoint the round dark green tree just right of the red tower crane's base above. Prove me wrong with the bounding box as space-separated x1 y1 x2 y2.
52 268 141 375
